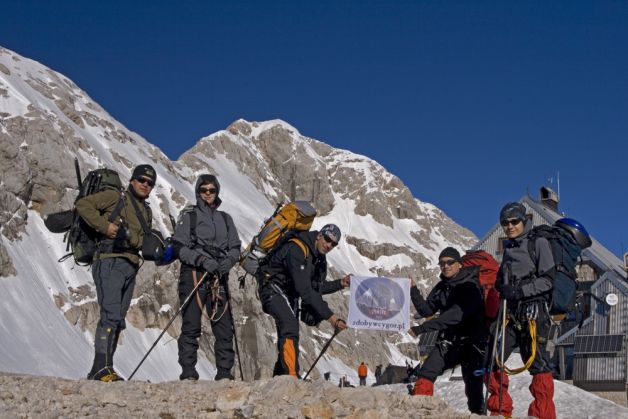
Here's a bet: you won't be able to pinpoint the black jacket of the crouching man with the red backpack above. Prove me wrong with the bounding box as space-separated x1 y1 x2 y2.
410 266 486 340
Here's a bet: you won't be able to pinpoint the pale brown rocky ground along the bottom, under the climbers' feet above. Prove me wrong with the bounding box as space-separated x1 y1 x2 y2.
0 374 475 419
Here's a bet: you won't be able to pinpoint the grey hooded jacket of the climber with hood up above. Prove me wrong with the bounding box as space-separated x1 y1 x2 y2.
173 177 241 267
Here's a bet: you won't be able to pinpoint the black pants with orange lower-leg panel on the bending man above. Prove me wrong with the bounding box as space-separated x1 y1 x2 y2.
259 284 299 377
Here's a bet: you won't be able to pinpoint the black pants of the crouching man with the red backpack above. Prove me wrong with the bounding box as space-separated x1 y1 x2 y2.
418 339 485 414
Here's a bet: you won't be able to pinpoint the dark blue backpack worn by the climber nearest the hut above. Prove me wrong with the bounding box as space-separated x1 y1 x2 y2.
528 218 592 315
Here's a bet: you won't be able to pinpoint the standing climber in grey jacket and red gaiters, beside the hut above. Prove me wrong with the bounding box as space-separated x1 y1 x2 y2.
486 202 556 419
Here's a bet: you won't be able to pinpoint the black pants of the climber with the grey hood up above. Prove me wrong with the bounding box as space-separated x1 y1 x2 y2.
177 270 235 379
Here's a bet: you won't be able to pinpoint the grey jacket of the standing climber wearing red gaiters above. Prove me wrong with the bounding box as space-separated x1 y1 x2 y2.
497 220 556 300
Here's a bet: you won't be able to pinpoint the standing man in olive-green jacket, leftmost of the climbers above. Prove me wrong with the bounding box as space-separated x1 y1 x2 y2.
76 164 157 381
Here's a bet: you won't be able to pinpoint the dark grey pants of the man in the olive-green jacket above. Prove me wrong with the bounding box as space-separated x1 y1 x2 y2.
92 257 137 366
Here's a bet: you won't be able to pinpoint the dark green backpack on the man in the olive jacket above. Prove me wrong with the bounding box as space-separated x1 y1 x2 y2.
59 168 124 266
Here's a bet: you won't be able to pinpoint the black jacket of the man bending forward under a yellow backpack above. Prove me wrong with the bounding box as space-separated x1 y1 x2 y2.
260 231 342 319
